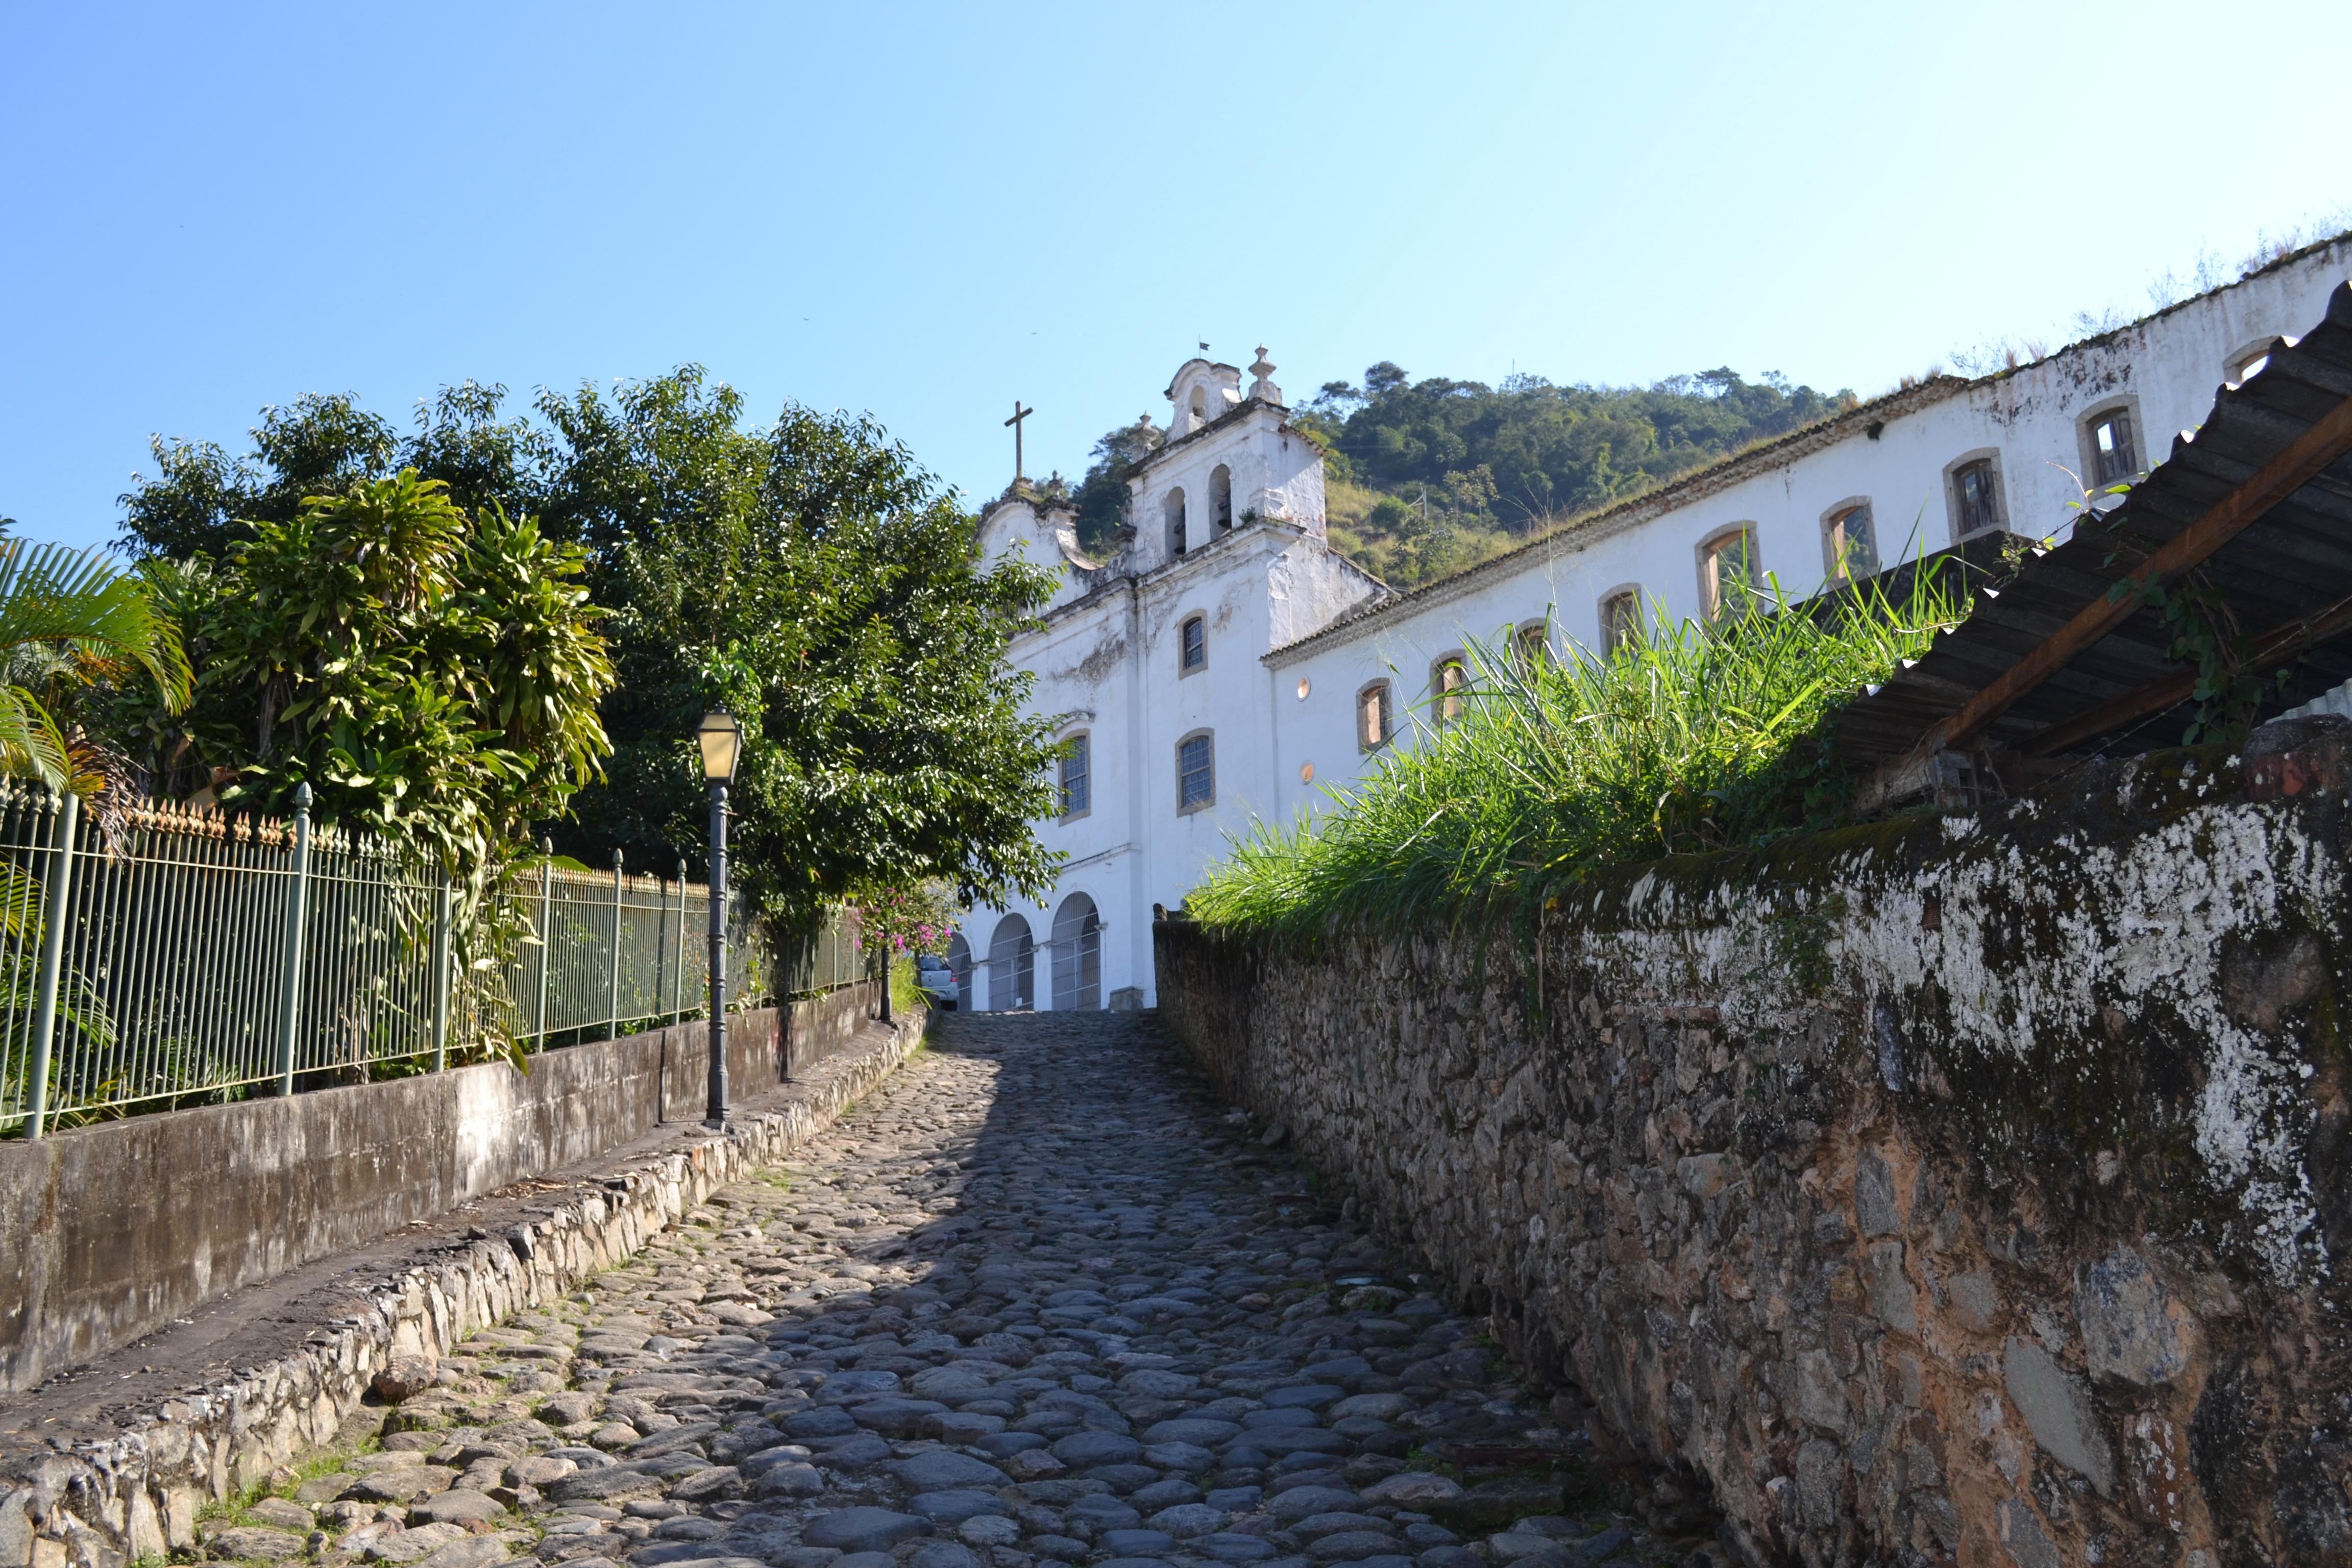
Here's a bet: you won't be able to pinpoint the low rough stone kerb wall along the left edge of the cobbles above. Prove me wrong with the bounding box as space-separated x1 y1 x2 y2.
0 1013 927 1568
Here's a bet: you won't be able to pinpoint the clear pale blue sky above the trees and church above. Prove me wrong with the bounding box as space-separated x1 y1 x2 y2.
0 0 2352 541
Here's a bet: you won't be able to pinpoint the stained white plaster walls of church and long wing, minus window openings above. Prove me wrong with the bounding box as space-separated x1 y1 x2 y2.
964 242 2352 1006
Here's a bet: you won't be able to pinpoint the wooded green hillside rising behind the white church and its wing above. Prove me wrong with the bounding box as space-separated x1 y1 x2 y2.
1075 360 1856 587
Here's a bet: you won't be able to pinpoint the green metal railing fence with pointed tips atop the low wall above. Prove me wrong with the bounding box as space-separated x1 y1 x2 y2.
0 778 866 1138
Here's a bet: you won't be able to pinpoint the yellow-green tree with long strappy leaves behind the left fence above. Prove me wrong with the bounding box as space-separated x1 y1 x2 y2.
132 468 614 874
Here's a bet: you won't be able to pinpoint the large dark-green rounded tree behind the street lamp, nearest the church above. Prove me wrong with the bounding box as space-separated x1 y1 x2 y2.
541 369 1056 924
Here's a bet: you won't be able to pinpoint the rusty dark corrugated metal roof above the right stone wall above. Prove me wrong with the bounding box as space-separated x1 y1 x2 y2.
1842 284 2352 795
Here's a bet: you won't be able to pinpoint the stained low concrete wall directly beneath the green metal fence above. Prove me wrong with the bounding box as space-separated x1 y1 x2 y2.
0 985 879 1392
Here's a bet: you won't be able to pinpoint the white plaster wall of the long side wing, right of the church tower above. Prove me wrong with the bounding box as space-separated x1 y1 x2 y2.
1268 242 2352 818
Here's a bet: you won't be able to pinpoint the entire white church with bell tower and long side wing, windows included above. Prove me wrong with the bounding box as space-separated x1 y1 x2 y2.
950 237 2352 1009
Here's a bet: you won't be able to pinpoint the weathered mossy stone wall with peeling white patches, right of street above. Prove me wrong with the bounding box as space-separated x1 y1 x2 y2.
1157 752 2352 1568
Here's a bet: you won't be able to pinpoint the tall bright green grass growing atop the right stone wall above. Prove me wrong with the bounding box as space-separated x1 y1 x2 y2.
1185 562 1969 943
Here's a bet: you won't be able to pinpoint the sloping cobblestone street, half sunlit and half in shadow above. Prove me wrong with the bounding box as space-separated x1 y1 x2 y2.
205 1013 1714 1568
